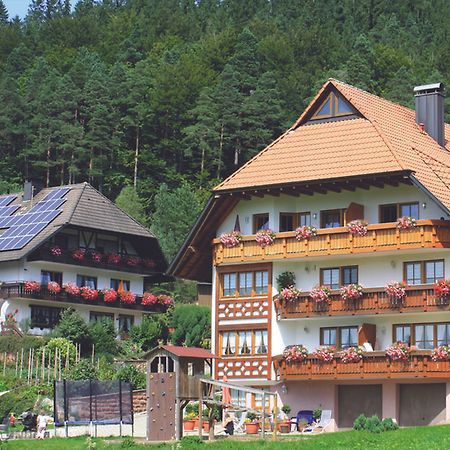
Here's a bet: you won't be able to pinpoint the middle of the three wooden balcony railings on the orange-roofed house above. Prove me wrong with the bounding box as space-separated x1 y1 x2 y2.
274 285 450 319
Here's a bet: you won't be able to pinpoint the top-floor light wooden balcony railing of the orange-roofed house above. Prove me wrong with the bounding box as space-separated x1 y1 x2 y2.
213 220 450 265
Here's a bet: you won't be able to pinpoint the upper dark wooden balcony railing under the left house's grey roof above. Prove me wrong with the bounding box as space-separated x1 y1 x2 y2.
28 246 161 275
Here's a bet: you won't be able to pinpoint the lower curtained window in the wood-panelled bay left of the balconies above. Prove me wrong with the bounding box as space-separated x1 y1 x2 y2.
220 330 268 356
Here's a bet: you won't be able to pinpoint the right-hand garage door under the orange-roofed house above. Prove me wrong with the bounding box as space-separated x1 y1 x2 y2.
399 383 445 427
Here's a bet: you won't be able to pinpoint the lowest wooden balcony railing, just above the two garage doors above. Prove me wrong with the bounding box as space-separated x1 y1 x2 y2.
274 350 450 381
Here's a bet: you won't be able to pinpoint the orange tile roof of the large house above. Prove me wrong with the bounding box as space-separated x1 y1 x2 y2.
215 79 450 208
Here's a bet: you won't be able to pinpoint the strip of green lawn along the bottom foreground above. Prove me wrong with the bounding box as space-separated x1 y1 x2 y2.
0 425 450 450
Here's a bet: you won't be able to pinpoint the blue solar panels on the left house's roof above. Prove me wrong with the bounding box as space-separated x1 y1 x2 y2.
0 188 70 251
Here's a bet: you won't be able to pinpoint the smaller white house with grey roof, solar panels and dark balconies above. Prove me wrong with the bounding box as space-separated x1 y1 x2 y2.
0 183 167 334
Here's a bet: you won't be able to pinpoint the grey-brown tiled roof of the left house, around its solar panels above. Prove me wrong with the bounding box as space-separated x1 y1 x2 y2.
0 183 165 264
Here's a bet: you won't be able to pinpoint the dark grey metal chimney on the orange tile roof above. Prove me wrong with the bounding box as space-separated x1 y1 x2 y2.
414 83 445 147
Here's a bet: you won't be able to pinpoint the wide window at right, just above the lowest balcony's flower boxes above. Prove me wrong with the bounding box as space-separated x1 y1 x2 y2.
393 323 450 350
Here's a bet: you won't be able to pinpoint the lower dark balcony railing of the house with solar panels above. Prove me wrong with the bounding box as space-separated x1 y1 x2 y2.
0 282 167 313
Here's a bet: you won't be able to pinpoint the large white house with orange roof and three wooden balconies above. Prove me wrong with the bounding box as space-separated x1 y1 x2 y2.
168 79 450 428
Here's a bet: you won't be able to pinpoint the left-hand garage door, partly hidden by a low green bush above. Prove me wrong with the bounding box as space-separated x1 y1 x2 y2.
338 384 382 428
